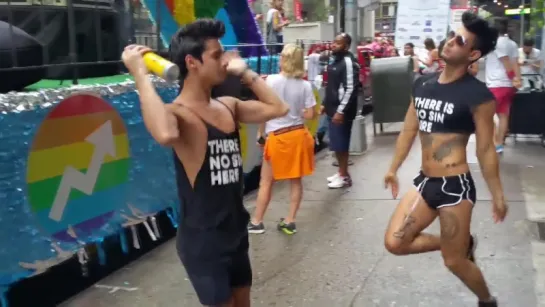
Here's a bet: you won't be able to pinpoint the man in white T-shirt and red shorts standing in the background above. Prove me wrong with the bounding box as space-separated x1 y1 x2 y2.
485 17 521 153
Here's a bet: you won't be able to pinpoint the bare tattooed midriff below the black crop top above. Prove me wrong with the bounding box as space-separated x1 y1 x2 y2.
419 132 469 177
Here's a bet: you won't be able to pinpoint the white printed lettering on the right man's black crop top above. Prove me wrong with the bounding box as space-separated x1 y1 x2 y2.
414 97 454 133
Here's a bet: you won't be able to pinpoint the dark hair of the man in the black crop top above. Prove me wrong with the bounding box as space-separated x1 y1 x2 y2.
462 12 498 57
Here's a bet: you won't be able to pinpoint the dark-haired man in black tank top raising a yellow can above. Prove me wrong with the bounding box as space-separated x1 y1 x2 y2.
122 19 289 307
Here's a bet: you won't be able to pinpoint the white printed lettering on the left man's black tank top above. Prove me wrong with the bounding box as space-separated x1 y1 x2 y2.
208 139 242 187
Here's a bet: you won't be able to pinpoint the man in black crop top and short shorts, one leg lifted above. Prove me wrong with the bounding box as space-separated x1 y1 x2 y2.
384 12 507 306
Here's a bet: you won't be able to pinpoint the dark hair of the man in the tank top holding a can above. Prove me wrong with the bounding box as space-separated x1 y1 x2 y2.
169 18 225 80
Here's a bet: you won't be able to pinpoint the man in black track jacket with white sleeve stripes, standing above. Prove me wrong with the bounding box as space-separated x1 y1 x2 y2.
321 33 360 189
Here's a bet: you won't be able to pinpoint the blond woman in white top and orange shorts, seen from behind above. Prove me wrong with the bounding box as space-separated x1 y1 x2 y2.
248 44 316 234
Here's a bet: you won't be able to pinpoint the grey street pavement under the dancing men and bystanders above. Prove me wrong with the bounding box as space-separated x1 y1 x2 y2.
61 124 545 307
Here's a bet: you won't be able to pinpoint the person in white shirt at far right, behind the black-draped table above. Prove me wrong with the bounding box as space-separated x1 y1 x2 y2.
519 38 543 88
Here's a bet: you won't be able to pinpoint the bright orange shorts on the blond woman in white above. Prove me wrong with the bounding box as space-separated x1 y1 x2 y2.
263 125 314 180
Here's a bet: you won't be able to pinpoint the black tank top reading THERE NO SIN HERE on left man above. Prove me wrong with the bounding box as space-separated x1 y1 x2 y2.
174 100 250 259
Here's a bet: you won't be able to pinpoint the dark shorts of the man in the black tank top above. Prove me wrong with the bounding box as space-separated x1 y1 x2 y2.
180 251 252 306
